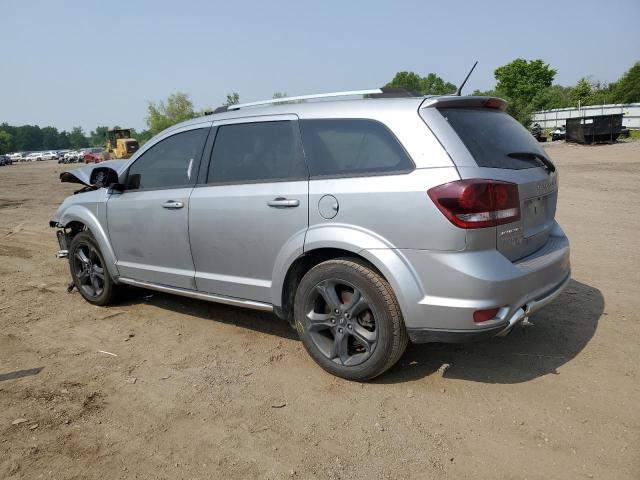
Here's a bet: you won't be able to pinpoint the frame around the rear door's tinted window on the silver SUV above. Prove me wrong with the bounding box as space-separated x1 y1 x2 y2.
200 118 309 188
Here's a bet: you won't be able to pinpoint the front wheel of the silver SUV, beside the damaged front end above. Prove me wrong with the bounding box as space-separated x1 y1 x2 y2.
68 230 121 306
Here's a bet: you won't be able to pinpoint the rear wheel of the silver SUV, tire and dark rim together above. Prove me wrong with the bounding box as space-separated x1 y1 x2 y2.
294 258 408 381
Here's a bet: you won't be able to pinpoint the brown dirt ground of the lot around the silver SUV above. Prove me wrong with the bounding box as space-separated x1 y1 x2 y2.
0 142 640 480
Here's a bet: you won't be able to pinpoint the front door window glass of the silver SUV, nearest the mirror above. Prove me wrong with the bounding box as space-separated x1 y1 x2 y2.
127 127 209 189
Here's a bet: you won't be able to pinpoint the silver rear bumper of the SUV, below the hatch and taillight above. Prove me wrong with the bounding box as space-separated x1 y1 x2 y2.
402 224 571 343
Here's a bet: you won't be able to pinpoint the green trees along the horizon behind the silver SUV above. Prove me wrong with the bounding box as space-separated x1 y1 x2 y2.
0 58 640 154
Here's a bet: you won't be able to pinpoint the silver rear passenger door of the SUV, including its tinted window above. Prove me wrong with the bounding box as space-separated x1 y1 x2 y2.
189 115 309 303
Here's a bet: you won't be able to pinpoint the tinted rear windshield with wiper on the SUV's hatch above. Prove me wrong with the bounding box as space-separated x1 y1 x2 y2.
438 108 547 170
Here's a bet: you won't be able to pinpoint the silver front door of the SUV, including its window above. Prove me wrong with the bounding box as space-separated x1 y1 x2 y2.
107 124 210 289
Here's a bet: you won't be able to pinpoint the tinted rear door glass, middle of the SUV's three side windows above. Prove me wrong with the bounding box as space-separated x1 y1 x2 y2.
207 120 309 183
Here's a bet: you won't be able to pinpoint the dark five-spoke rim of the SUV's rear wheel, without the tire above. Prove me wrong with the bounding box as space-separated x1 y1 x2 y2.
305 279 378 367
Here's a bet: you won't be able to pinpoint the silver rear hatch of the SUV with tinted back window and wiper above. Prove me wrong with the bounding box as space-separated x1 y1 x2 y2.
420 97 558 261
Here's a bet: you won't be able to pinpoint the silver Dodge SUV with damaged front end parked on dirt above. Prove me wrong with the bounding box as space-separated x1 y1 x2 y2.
50 91 570 380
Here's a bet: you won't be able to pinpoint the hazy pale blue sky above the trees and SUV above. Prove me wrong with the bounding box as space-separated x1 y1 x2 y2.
0 0 640 130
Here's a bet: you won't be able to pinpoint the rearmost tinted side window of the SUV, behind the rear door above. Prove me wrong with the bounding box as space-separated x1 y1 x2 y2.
300 119 414 177
